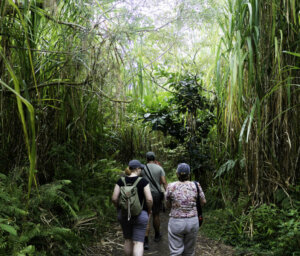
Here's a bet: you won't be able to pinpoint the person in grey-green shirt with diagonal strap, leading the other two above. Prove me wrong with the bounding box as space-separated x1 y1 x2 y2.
141 152 167 250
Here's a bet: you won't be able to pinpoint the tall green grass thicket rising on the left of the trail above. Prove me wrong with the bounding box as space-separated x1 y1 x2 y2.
0 0 134 179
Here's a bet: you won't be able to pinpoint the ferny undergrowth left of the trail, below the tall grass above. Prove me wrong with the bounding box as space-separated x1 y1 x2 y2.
0 152 120 256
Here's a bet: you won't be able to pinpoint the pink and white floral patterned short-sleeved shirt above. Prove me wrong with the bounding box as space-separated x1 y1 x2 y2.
166 181 205 218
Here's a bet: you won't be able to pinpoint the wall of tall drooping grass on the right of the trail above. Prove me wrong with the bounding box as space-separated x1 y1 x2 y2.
216 0 300 202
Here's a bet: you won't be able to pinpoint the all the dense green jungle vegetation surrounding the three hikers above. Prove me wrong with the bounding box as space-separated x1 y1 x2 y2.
0 0 300 256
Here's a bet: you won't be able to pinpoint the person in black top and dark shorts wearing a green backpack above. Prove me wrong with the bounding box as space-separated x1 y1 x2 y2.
112 160 153 256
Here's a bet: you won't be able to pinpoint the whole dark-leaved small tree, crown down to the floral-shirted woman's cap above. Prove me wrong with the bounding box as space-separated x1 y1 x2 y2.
143 71 215 183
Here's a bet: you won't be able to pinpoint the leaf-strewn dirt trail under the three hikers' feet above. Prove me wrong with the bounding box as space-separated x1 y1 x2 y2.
84 213 234 256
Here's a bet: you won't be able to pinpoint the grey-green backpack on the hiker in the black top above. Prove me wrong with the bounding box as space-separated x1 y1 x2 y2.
119 177 144 220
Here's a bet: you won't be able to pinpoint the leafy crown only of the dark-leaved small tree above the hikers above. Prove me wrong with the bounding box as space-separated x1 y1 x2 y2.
143 70 215 142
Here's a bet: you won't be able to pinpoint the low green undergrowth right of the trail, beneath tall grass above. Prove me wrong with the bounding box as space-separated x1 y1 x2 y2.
201 187 300 256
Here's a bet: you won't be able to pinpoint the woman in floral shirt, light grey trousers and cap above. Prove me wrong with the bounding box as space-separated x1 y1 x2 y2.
166 163 206 256
